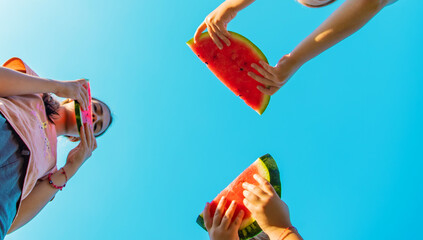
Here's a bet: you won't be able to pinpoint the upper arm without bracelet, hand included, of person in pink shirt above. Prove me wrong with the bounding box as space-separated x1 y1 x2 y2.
0 67 88 109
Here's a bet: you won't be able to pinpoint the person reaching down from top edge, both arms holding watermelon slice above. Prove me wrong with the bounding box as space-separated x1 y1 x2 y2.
194 0 397 95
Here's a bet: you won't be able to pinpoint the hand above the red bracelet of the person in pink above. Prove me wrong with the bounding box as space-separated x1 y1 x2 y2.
66 123 97 175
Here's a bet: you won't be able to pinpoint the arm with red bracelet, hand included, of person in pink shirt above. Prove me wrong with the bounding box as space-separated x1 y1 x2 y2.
8 124 97 233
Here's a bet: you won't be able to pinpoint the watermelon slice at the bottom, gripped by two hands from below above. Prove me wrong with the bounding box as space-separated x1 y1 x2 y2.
197 154 281 240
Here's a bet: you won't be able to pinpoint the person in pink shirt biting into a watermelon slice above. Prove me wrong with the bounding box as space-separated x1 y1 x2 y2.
0 58 112 240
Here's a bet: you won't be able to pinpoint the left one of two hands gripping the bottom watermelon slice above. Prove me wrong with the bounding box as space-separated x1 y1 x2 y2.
203 197 244 240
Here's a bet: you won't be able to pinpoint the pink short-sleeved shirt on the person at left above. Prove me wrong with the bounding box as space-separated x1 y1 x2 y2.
0 58 57 219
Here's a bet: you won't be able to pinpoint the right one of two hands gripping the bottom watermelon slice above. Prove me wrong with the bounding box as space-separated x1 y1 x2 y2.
242 174 292 236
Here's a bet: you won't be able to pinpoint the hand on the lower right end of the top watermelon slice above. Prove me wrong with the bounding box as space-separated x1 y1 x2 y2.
248 54 300 95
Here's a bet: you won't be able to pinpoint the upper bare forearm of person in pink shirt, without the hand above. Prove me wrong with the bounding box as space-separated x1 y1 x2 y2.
0 67 58 97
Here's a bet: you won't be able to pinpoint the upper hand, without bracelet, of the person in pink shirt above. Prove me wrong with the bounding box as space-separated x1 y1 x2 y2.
54 79 89 110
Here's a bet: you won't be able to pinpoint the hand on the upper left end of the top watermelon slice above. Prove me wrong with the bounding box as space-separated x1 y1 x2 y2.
194 2 237 49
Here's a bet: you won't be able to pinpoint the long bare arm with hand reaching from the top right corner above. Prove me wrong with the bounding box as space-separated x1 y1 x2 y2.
248 0 391 95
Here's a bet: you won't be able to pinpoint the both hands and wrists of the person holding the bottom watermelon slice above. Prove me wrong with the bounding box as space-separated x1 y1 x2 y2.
203 174 302 240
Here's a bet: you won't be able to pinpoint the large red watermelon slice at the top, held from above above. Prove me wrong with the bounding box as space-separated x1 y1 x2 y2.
187 32 270 115
